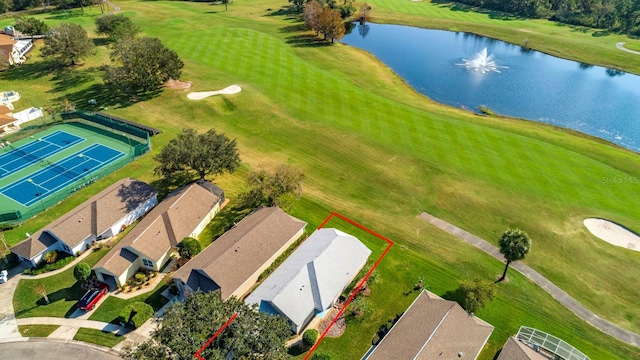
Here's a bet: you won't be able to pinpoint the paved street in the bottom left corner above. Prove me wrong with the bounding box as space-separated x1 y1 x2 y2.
0 339 121 360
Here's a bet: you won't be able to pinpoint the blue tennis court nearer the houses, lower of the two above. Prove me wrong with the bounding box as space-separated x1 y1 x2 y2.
0 144 126 206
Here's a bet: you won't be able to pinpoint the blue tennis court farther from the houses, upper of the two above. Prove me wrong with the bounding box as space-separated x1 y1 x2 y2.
0 130 85 178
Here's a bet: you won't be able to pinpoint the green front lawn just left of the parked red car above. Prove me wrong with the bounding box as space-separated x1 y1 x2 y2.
13 248 108 318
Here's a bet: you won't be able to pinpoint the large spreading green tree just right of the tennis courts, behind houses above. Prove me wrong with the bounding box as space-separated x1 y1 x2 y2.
155 128 240 179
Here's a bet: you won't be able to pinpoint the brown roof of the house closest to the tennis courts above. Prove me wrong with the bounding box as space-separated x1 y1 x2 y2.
11 178 156 259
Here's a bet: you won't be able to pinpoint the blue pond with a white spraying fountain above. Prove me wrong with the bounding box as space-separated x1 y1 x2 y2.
342 23 640 151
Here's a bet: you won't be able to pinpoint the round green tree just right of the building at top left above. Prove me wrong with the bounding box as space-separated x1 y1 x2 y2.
41 24 94 65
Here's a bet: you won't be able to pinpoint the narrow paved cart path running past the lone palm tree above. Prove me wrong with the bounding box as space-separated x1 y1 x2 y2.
418 212 640 347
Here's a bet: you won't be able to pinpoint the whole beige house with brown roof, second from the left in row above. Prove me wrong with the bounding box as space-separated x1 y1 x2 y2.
93 181 224 289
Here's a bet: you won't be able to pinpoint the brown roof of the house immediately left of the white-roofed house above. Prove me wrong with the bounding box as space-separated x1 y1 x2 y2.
173 207 307 299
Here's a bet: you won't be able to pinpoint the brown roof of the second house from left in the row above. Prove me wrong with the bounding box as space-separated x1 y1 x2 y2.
93 183 220 275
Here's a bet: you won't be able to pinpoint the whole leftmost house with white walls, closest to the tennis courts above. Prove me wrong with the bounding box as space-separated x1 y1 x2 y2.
11 178 158 266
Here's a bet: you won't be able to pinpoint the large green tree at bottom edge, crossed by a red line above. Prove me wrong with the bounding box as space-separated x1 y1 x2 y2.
123 291 291 360
